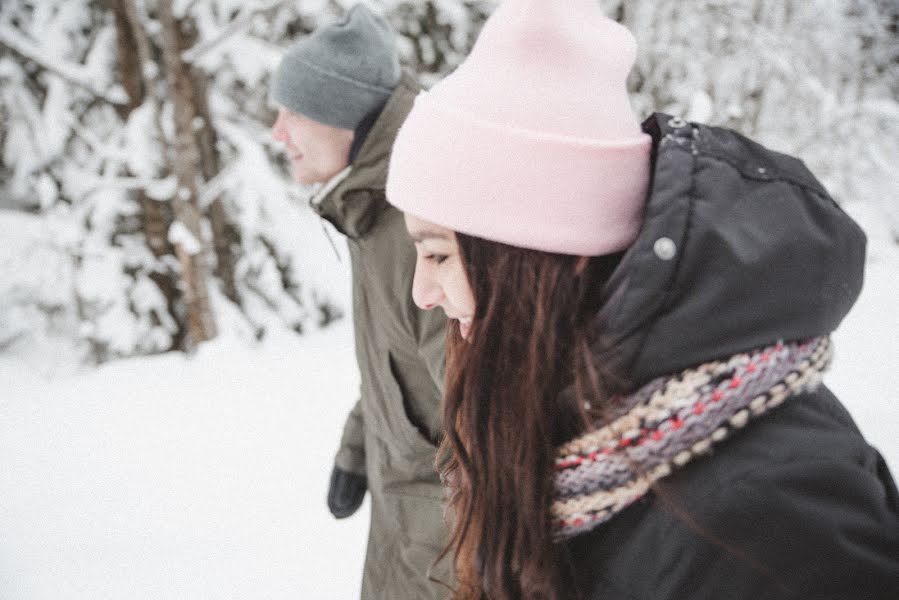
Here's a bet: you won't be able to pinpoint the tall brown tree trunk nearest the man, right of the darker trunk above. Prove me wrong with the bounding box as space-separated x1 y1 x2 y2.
158 0 216 344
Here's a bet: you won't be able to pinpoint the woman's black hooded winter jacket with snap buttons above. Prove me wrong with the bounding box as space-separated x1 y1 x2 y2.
564 114 899 600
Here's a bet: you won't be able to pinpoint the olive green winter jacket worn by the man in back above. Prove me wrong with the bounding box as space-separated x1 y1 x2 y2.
314 75 451 600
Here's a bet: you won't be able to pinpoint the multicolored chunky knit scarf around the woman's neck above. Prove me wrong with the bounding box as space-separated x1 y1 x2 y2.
551 337 832 541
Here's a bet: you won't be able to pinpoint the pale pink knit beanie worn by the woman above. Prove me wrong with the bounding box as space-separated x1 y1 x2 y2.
387 0 650 256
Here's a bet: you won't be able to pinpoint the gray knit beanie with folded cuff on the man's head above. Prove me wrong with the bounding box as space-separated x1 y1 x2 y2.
272 4 400 129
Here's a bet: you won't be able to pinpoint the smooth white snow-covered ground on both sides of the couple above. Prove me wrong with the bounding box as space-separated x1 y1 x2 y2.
0 204 899 600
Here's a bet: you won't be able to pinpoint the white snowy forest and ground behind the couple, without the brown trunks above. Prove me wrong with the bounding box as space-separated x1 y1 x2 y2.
0 0 899 600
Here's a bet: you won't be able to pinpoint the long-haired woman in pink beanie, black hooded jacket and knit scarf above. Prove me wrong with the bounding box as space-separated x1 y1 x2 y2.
387 0 899 600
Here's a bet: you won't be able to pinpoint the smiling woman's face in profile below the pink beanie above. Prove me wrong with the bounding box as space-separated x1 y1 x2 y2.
405 214 475 339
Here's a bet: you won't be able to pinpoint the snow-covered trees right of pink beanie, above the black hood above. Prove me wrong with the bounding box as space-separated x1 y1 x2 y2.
604 0 899 242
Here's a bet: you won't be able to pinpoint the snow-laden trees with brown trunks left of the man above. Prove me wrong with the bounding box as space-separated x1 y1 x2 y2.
0 0 356 362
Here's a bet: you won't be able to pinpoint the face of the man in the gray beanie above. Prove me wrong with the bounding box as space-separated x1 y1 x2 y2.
272 106 353 184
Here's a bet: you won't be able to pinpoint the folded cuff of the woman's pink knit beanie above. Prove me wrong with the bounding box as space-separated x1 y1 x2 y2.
387 93 651 256
